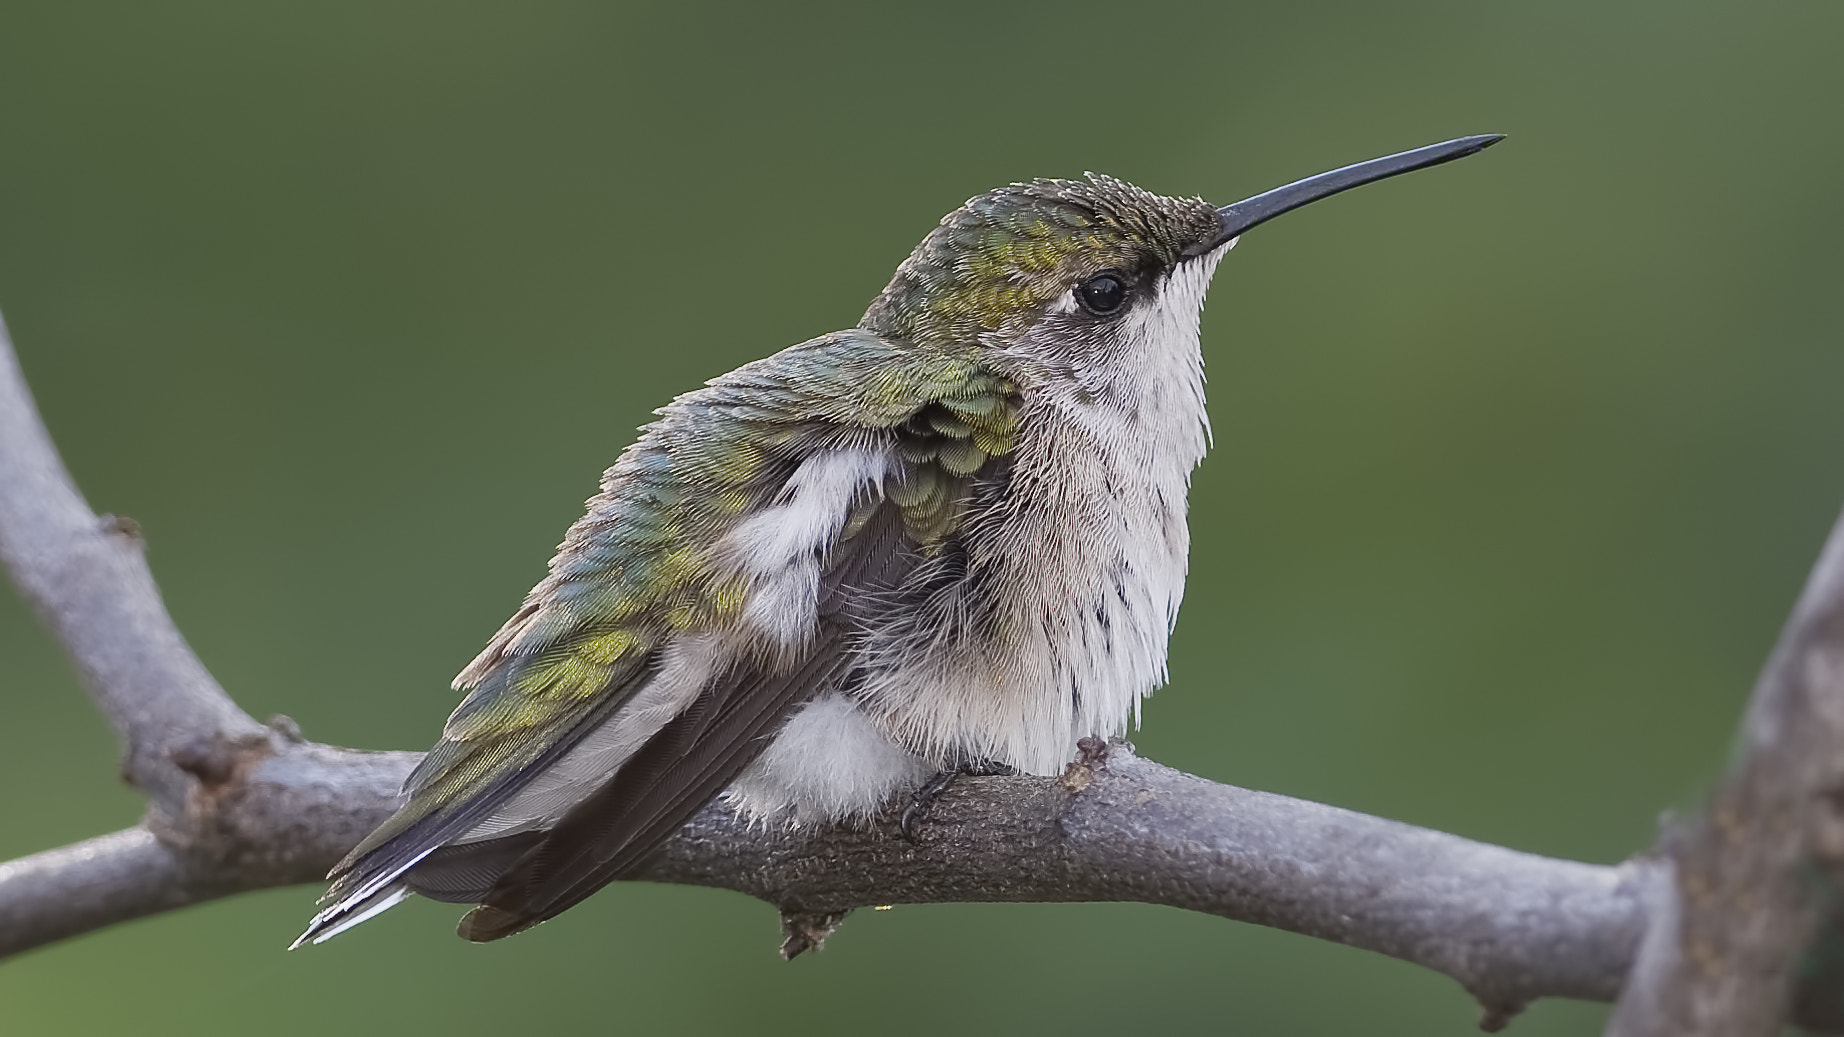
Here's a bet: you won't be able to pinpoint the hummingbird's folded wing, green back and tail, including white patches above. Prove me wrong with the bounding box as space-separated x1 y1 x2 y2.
297 332 1016 943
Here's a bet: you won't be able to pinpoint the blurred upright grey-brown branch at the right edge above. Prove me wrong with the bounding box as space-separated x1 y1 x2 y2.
1608 505 1844 1037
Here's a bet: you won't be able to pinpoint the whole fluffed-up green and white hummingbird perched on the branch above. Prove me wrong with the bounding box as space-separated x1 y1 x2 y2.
295 135 1503 947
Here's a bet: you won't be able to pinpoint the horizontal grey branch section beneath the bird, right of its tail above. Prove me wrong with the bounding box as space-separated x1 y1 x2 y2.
638 744 1658 1028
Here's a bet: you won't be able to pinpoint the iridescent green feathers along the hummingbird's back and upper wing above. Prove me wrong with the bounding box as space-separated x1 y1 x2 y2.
343 330 1018 867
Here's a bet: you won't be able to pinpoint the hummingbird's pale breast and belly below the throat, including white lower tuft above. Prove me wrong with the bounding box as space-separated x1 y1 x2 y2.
732 397 1204 819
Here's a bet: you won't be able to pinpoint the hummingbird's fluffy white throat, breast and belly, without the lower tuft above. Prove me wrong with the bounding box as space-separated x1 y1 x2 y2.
863 245 1228 775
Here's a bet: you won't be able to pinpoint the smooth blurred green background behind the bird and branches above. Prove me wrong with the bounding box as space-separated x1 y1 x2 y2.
0 0 1844 1037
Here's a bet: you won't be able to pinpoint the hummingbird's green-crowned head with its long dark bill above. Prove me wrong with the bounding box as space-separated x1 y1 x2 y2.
863 135 1503 380
